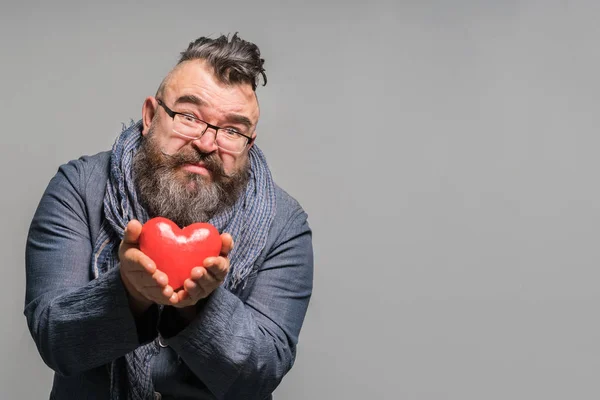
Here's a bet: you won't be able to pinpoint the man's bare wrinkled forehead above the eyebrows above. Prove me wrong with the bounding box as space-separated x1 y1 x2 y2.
164 60 259 124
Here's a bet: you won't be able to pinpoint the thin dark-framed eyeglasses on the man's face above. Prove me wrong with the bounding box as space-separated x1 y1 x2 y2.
156 99 253 153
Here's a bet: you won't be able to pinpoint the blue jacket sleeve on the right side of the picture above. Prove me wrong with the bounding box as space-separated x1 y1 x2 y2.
159 209 313 400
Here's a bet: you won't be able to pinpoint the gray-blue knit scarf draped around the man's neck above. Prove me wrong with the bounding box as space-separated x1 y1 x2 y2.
92 121 275 400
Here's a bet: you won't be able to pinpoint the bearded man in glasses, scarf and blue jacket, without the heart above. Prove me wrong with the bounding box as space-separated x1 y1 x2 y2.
25 35 313 399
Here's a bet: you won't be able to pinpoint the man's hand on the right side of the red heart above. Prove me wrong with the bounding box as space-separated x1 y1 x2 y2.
171 233 233 308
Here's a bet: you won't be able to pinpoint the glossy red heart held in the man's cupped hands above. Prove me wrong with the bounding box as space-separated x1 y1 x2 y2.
139 217 222 290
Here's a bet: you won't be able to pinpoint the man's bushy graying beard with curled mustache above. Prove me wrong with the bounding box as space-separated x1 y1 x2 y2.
133 129 250 228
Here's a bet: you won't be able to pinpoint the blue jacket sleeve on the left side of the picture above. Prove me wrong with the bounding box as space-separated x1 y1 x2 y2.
24 161 152 375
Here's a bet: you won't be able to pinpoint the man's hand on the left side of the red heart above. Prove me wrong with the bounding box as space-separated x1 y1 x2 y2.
119 220 177 315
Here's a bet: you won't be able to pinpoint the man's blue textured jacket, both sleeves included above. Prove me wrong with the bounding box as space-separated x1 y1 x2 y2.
25 152 313 399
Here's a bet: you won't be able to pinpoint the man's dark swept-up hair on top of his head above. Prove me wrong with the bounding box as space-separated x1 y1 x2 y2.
177 32 267 91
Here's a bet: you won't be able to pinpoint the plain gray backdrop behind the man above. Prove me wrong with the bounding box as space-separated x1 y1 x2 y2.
0 0 600 400
